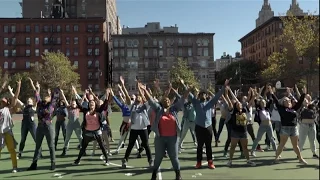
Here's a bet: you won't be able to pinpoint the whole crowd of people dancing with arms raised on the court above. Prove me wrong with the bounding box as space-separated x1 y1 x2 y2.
0 77 319 180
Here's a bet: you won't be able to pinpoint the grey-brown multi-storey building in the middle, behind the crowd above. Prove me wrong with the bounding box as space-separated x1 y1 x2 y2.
112 23 215 93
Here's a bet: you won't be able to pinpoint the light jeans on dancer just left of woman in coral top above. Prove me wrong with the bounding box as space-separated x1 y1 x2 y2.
63 119 82 149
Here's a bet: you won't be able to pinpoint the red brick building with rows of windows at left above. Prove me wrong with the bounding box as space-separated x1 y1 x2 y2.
0 18 109 90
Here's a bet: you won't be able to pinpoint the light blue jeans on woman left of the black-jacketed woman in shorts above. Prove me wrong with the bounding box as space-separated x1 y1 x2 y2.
252 124 277 151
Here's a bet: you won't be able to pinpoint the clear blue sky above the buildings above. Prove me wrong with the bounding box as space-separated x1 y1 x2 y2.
0 0 319 59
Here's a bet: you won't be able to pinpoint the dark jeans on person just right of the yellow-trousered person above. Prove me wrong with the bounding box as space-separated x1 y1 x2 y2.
19 121 37 153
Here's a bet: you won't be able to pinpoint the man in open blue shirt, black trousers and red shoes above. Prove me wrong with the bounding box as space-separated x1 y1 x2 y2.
180 79 229 169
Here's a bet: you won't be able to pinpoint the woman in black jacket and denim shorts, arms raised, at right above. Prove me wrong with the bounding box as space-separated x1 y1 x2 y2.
268 86 307 165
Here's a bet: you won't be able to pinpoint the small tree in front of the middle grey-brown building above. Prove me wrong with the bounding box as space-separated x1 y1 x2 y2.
169 58 199 92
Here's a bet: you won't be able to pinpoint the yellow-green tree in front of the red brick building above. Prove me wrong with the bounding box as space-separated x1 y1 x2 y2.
30 52 80 95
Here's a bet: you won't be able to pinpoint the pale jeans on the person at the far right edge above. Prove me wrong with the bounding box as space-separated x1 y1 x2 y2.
299 123 316 154
